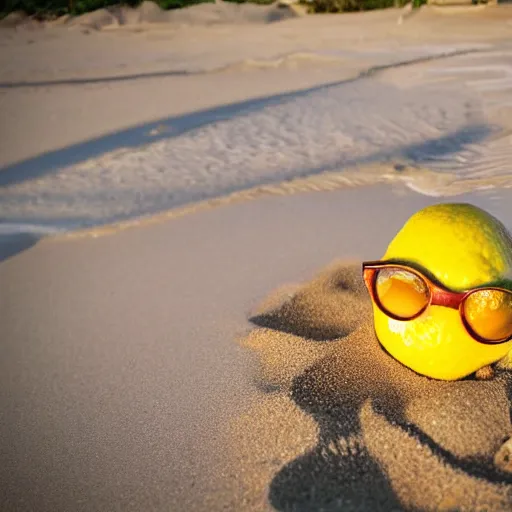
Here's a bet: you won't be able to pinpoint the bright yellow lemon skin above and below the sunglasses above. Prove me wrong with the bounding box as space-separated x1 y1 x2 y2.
373 203 512 380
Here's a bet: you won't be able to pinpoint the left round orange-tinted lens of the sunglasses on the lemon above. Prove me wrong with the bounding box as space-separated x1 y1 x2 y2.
375 267 430 320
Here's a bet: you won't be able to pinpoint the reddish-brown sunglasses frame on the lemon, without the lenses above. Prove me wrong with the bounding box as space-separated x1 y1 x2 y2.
362 261 512 345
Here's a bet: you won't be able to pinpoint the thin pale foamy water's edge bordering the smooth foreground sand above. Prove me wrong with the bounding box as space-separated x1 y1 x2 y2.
0 162 512 239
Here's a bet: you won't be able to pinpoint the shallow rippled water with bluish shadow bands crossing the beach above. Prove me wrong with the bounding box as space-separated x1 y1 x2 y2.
0 44 512 232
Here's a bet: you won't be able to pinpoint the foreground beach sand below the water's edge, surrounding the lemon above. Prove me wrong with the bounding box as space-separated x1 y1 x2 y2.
0 185 512 511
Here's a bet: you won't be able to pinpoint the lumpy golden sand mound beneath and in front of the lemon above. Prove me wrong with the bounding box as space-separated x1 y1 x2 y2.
233 265 512 511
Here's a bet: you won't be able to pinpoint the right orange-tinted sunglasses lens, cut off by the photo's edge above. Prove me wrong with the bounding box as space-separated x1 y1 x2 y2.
464 290 512 342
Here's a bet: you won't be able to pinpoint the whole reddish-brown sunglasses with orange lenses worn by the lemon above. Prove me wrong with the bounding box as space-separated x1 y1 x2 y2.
363 261 512 344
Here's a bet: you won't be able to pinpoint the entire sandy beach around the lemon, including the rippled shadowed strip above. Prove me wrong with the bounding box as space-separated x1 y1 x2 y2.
0 4 512 512
